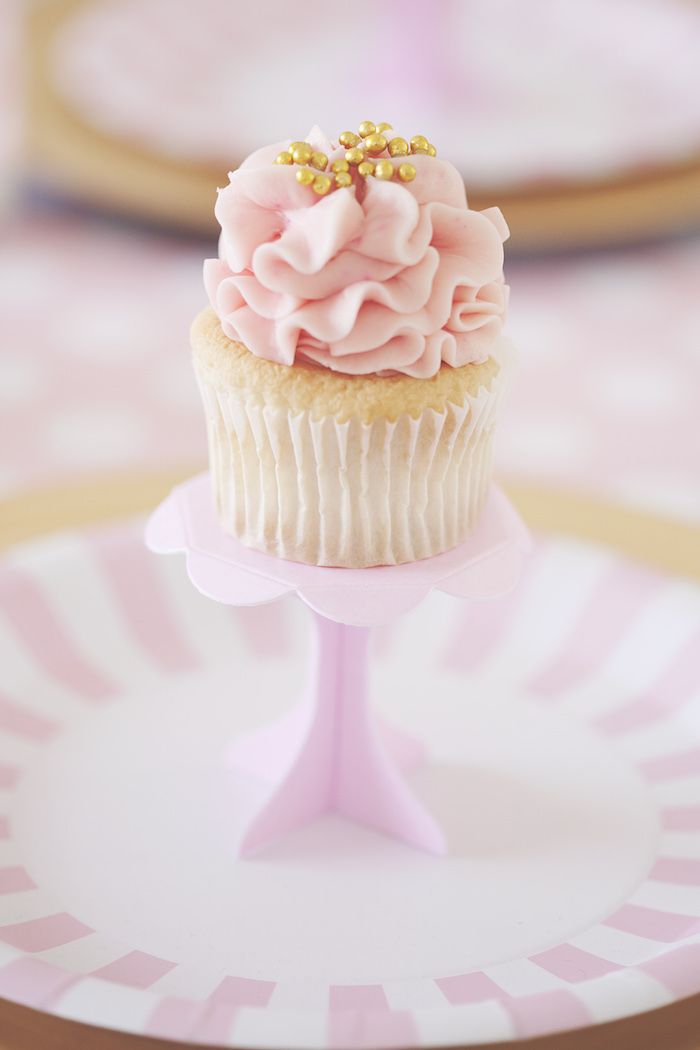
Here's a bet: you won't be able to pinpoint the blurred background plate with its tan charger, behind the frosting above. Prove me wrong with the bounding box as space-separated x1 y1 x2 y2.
24 0 700 248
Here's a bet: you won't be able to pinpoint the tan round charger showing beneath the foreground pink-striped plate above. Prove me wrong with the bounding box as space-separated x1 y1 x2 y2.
0 470 700 1050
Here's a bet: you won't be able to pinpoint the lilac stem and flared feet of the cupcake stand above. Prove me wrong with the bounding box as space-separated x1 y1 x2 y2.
232 612 446 855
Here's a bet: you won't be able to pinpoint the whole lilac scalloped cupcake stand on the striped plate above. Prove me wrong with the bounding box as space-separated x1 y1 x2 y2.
146 475 530 856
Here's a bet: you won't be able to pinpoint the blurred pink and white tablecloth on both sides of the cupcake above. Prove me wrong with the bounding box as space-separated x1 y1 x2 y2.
0 217 700 521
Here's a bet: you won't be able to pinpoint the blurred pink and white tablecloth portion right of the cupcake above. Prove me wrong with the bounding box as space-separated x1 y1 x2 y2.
500 239 700 521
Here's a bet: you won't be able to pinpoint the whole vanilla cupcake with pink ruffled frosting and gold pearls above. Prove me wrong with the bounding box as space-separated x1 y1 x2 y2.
192 122 512 568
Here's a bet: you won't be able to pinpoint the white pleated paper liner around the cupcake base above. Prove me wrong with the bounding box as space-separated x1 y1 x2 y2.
197 356 504 568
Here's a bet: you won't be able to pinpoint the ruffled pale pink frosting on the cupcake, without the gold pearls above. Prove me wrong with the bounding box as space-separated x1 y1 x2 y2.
205 129 508 378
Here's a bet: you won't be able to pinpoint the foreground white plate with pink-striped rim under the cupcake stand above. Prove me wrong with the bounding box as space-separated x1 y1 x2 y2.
0 523 700 1050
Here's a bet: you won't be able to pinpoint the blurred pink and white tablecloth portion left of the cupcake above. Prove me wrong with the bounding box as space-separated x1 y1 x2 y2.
0 219 206 494
